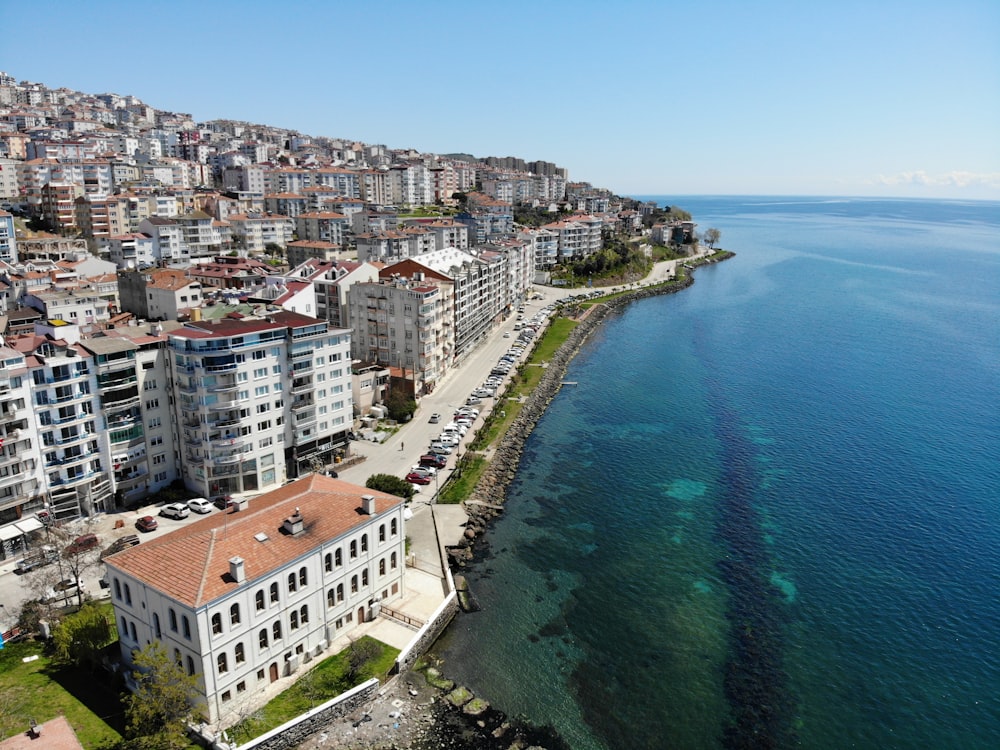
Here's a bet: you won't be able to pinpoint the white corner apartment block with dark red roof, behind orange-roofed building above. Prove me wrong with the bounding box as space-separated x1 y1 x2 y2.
168 311 353 497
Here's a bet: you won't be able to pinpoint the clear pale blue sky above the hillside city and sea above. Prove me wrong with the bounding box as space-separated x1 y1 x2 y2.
0 0 1000 199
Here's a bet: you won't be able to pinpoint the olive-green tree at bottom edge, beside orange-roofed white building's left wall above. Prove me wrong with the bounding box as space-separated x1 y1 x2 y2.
125 641 198 748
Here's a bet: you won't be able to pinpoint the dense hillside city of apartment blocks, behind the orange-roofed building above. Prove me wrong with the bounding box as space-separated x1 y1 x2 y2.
0 73 697 536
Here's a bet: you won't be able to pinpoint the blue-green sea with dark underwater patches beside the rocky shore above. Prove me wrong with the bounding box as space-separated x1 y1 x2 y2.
436 196 1000 750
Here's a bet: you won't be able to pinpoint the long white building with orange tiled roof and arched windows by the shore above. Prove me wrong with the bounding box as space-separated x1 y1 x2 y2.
105 474 406 727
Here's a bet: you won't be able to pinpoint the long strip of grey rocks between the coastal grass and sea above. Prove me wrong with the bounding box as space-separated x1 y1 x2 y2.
448 251 734 567
